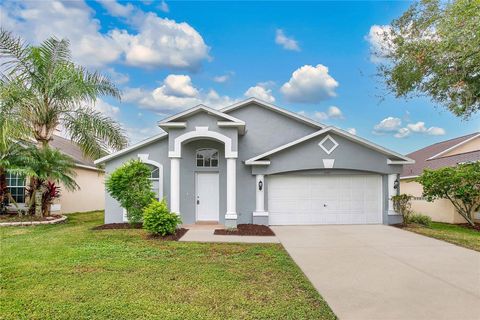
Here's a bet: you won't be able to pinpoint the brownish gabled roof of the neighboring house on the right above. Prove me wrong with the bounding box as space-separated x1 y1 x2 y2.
400 132 480 178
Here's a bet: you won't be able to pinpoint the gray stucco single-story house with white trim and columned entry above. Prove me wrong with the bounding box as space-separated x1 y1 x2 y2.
95 98 413 226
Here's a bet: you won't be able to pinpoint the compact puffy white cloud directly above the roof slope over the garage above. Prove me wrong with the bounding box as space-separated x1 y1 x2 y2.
280 64 338 103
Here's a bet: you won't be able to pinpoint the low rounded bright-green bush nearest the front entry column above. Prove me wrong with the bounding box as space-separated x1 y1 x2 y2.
143 199 182 236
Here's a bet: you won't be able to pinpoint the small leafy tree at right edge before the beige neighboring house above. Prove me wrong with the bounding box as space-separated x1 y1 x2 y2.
416 162 480 226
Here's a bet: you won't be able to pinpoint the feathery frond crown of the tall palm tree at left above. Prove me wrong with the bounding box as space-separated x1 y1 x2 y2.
0 29 127 158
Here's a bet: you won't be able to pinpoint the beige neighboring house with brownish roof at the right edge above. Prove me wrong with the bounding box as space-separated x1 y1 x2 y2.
400 132 480 223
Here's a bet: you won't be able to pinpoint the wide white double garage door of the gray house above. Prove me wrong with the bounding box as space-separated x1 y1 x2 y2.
267 175 382 225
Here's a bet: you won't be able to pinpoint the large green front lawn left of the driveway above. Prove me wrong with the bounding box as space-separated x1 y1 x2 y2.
0 212 335 319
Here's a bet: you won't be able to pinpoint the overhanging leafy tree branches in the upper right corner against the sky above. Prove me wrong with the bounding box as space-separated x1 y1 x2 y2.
374 0 480 119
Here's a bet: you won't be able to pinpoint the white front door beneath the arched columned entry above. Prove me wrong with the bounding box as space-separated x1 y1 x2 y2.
195 172 220 221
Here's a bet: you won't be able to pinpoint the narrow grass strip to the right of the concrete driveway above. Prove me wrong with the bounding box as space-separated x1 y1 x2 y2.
403 222 480 251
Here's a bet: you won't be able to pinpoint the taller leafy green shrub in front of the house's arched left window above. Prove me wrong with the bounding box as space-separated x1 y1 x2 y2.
105 160 155 223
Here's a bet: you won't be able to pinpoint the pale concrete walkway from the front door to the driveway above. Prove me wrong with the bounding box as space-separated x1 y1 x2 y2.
179 228 280 243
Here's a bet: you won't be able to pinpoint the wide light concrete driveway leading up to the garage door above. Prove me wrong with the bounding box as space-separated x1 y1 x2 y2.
272 225 480 320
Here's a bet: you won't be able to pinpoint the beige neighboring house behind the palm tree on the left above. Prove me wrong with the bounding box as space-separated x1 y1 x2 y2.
7 136 105 213
